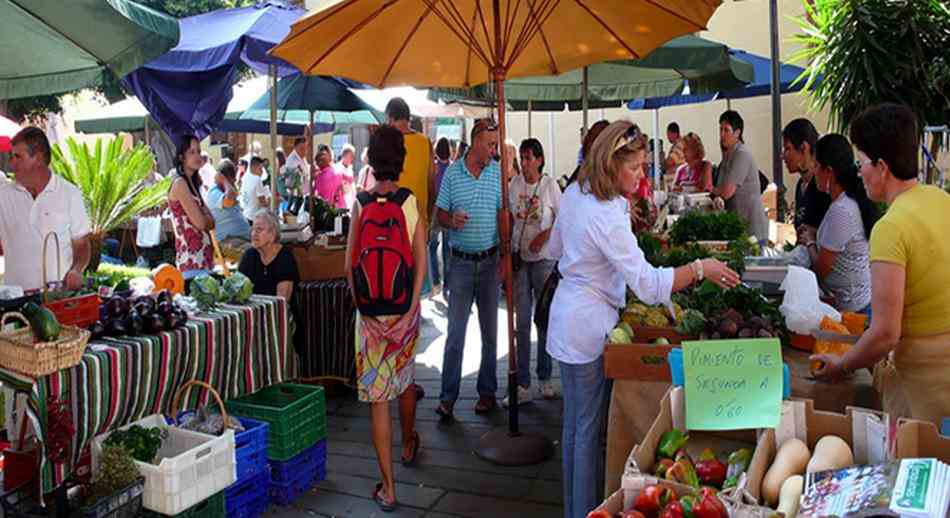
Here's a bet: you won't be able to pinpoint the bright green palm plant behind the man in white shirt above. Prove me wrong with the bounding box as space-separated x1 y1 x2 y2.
50 138 171 271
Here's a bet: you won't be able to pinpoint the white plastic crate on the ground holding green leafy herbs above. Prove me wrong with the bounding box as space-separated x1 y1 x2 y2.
92 414 237 515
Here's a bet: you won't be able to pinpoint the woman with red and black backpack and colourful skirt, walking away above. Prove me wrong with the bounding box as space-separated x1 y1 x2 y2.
346 126 428 512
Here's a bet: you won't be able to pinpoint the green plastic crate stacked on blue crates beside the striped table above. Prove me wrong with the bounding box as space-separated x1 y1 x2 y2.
226 383 327 462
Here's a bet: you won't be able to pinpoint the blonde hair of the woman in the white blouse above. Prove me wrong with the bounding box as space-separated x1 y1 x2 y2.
577 121 647 201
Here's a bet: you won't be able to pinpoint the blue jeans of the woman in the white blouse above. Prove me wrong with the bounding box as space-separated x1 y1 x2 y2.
558 356 607 518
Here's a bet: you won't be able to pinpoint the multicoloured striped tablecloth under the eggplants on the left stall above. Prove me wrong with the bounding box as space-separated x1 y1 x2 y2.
0 295 297 493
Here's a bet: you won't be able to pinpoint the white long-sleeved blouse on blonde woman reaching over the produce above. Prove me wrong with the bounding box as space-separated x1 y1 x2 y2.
547 182 673 364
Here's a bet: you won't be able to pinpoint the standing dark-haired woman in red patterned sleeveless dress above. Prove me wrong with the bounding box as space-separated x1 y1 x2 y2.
168 135 214 272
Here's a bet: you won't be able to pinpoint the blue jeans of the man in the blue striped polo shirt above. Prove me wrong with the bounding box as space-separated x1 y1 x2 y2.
439 254 498 403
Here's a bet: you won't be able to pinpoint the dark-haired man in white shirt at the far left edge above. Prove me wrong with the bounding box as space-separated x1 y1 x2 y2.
0 127 91 290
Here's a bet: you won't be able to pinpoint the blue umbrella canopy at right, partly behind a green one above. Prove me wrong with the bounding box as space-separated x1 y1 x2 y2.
627 49 821 110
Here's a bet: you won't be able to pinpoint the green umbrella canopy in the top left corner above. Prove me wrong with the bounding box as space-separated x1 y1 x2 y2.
0 0 179 99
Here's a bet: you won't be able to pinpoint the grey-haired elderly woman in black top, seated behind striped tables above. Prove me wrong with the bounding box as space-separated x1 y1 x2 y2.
238 211 300 300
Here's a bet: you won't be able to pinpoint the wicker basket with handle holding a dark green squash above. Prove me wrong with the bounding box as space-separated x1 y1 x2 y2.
0 311 90 378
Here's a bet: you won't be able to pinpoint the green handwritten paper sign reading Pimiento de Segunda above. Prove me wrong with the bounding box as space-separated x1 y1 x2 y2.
683 338 782 430
